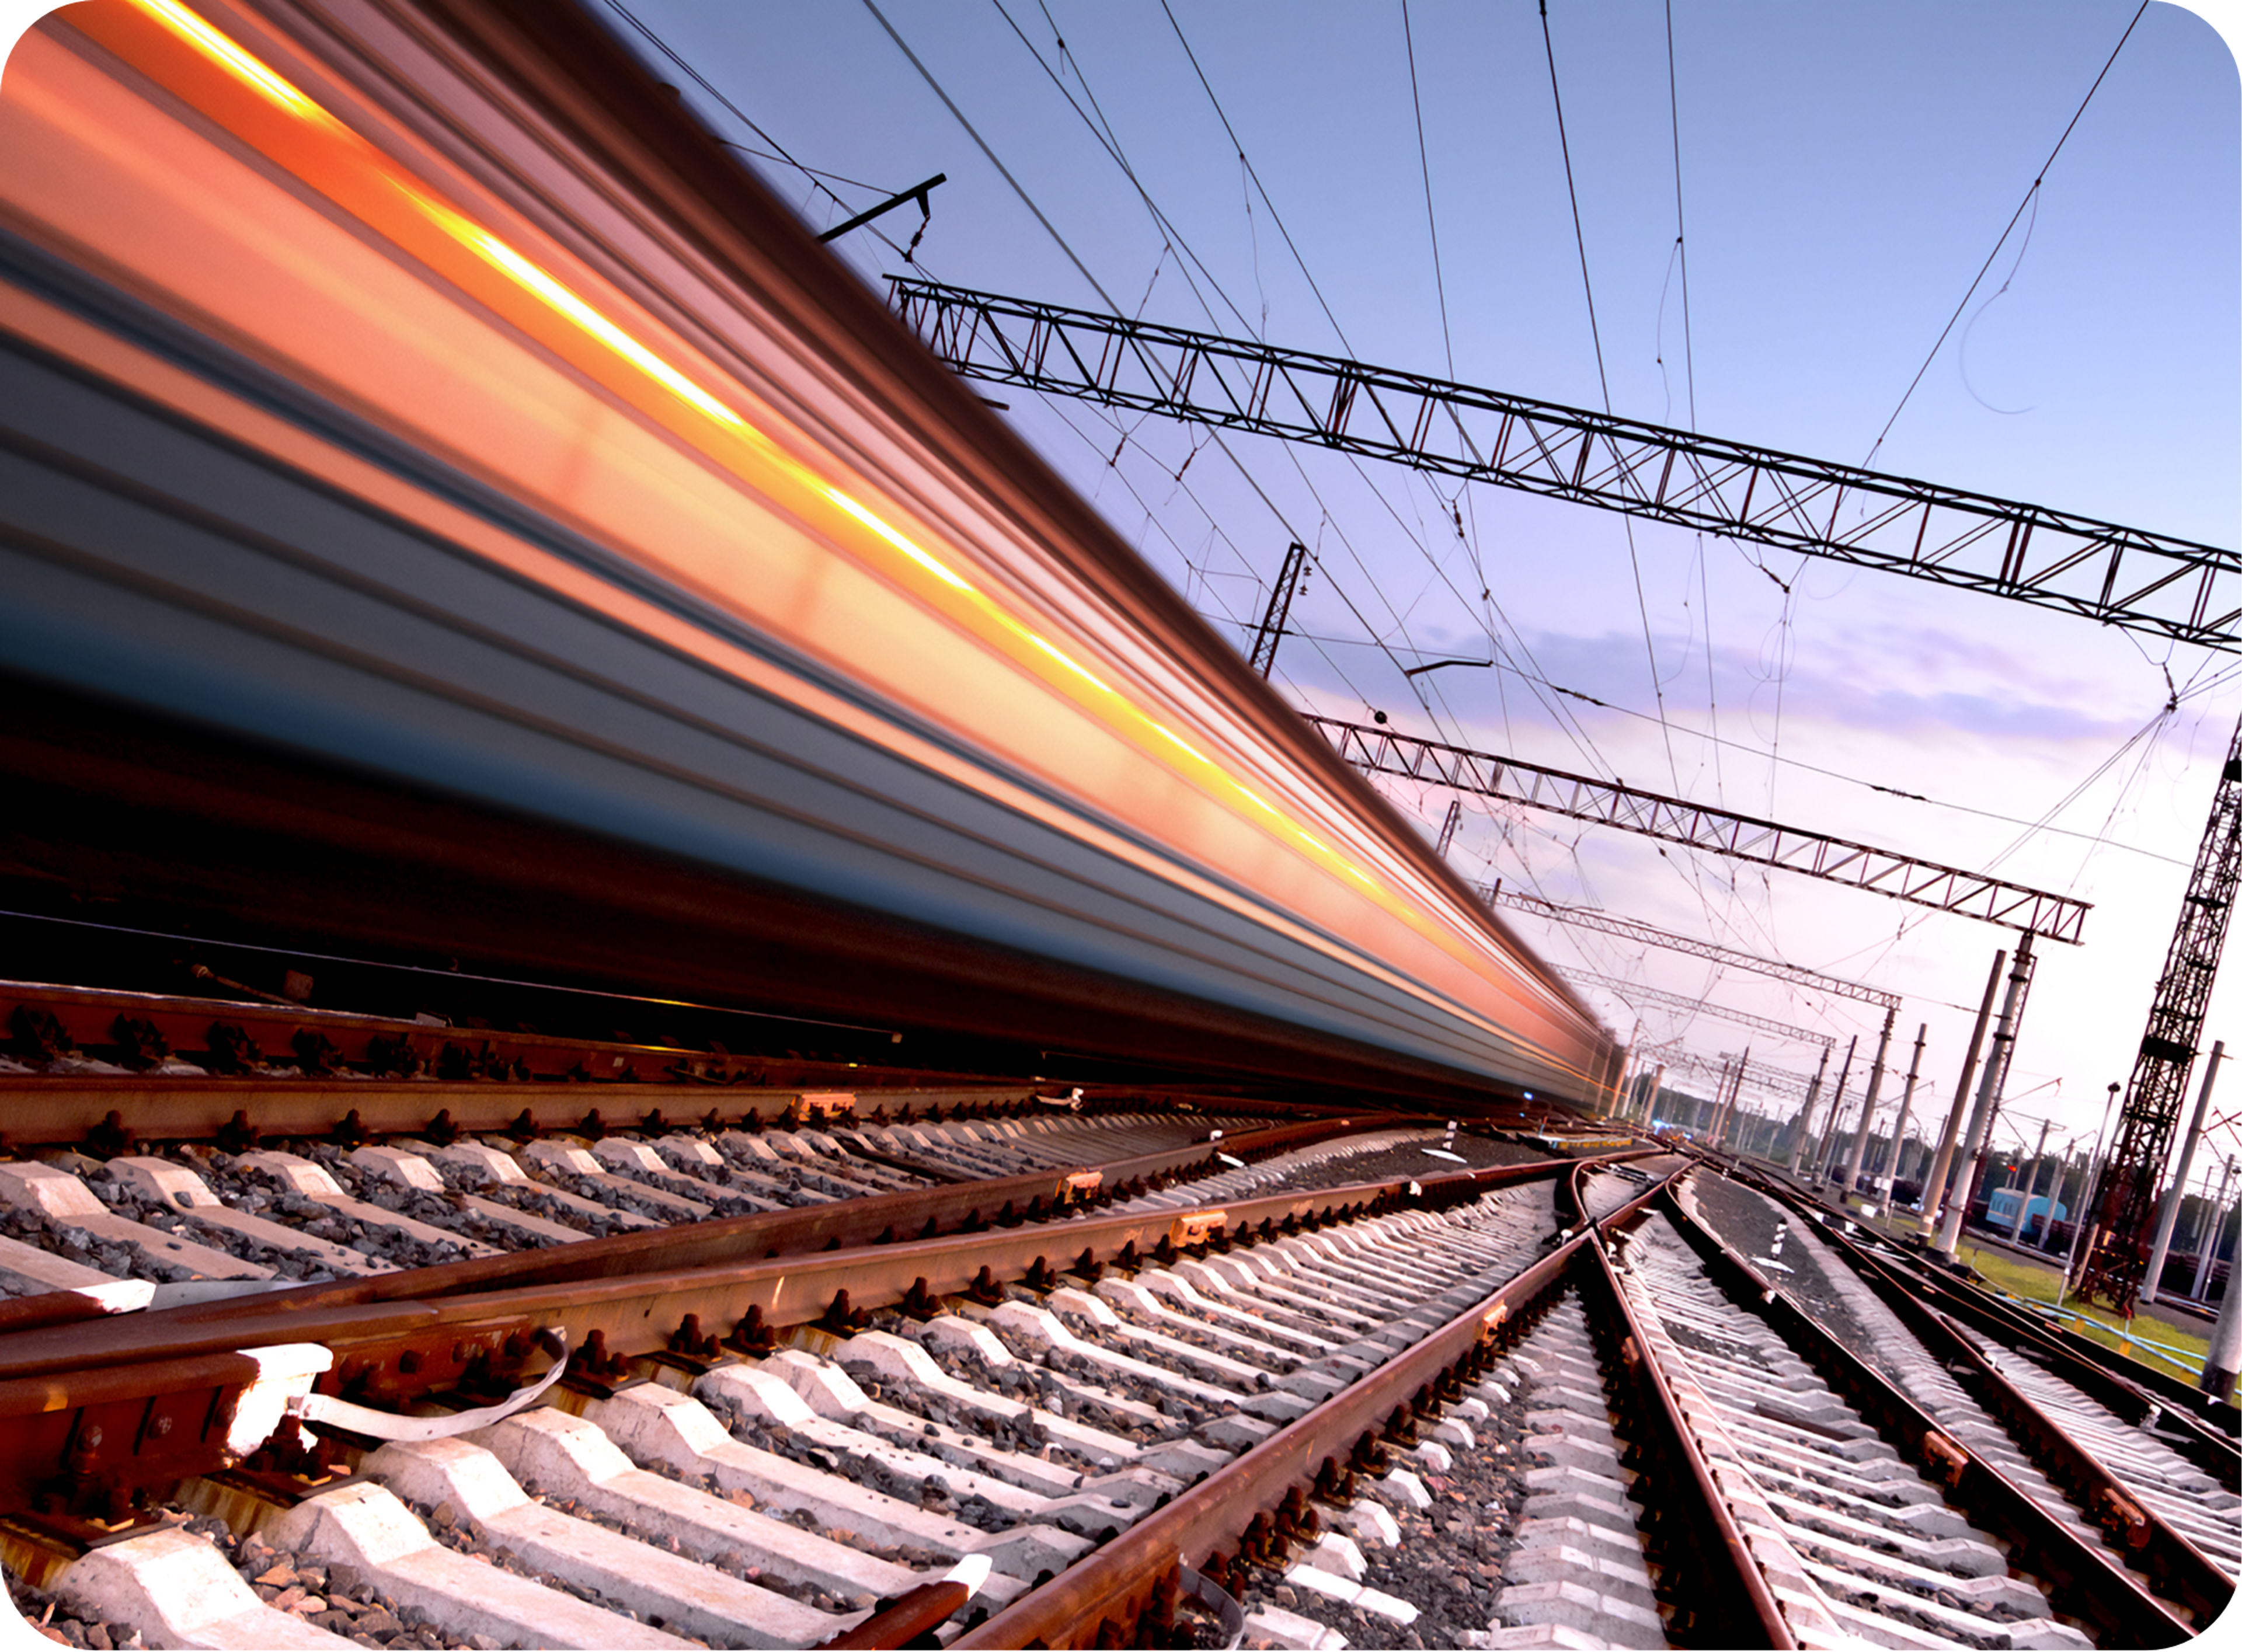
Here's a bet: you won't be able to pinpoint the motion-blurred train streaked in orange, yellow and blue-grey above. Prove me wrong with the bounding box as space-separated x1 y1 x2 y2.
0 0 1617 1100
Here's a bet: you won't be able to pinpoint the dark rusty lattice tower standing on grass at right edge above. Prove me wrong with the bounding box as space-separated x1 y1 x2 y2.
2072 724 2242 1313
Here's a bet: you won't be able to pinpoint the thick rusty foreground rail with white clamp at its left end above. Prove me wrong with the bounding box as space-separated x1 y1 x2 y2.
0 1150 1650 1542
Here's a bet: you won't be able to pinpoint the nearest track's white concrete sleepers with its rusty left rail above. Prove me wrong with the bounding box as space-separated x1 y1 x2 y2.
0 1130 1650 1645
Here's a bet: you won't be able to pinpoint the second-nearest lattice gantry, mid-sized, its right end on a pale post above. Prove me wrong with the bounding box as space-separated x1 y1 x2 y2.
1307 715 2092 944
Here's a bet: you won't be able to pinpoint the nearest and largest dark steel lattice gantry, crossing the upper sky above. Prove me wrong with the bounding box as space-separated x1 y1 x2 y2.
890 276 2242 652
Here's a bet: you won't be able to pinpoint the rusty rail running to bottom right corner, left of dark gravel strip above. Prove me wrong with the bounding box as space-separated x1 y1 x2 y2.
1666 1197 2195 1647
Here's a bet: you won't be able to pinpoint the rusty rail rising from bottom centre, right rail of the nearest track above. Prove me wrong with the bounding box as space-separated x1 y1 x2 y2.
948 1170 1686 1652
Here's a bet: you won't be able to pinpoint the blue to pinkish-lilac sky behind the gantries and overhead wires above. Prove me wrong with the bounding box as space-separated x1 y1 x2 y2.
628 0 2242 1163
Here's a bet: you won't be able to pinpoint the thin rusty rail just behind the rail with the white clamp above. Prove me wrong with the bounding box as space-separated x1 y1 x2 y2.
0 1116 1385 1365
